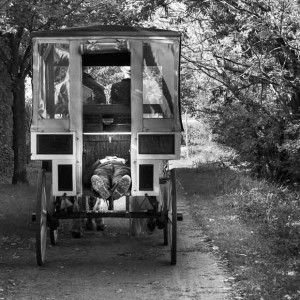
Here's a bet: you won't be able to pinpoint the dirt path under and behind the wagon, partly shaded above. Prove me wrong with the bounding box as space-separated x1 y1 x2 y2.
0 175 233 300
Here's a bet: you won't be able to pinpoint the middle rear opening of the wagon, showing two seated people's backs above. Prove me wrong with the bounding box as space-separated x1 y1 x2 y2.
82 65 131 132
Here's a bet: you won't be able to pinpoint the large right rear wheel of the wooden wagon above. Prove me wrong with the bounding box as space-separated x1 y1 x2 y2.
164 169 177 265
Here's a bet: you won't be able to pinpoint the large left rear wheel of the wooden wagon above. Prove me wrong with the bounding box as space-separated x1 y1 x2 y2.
36 169 47 266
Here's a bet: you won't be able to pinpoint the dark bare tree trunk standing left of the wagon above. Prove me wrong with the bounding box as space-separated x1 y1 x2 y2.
12 76 28 184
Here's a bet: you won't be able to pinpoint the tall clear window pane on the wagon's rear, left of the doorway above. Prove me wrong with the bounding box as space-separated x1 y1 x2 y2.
38 44 70 119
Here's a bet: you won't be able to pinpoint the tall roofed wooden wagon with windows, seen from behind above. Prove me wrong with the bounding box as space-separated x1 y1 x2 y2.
31 26 182 265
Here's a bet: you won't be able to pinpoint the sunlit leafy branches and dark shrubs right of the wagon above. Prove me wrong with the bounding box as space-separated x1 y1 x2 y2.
175 0 300 182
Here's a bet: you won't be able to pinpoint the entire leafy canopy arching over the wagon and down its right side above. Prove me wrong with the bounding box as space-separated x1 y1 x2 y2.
0 0 300 183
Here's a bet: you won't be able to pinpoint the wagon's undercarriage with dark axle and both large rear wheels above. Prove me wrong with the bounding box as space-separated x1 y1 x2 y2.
32 169 183 266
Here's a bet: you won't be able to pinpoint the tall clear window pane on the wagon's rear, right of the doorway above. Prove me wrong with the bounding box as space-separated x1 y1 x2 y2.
143 43 174 119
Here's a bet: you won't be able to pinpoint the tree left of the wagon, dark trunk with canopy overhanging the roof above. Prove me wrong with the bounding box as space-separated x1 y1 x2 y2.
0 0 145 184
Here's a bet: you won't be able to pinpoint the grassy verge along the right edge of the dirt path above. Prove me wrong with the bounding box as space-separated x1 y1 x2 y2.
178 159 300 300
